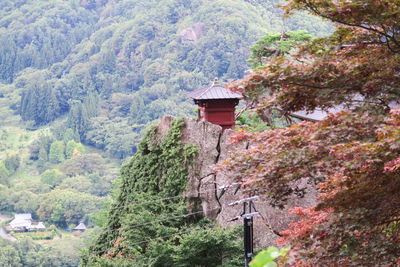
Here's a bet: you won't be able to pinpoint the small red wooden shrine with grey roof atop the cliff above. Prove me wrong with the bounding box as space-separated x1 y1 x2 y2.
188 79 242 129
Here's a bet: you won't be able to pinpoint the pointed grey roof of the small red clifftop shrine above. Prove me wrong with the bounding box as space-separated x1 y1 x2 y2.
188 79 243 100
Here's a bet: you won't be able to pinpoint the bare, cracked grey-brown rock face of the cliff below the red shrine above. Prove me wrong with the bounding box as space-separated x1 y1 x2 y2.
157 116 316 246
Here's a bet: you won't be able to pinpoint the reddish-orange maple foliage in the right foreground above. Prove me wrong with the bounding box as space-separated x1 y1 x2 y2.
221 0 400 266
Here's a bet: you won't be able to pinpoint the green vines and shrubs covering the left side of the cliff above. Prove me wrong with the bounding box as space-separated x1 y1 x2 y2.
83 119 240 266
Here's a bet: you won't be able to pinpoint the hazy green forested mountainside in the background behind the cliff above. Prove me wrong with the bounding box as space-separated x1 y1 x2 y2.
0 0 331 266
